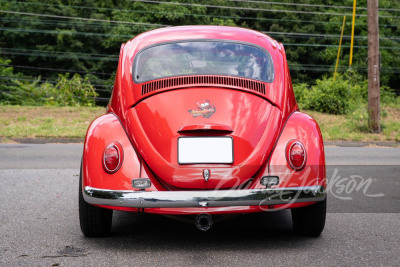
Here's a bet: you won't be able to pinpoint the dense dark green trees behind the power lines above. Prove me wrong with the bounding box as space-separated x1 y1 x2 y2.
0 0 400 97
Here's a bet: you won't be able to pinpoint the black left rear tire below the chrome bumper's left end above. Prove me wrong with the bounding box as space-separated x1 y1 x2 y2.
79 166 113 237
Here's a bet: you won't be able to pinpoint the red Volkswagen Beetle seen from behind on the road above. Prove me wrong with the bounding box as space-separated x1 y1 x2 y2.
79 26 326 237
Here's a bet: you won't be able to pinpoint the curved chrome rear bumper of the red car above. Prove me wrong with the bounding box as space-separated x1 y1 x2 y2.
83 186 326 208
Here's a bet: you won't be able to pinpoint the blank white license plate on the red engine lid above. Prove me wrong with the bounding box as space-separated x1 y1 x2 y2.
178 137 233 164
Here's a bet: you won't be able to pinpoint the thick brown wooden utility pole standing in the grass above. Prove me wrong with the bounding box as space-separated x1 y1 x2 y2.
367 0 381 133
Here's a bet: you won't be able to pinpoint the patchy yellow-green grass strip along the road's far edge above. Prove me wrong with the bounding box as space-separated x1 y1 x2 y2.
0 105 400 142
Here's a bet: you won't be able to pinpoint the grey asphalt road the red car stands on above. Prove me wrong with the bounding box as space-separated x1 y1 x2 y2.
0 144 400 266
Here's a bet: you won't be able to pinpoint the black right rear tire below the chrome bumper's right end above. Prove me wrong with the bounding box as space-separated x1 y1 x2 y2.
292 198 326 237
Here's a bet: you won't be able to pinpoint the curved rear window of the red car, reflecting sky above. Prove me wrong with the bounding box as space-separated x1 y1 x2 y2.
132 41 274 83
